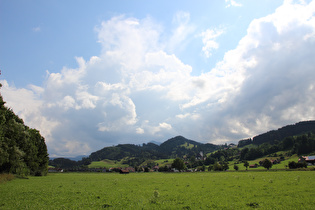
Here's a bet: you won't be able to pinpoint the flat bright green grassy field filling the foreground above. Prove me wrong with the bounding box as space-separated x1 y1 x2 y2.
0 171 315 209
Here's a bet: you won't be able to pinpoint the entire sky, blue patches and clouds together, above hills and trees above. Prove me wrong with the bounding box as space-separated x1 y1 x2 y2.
0 0 315 157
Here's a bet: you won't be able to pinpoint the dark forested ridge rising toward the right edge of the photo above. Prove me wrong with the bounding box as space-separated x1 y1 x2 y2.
238 121 315 147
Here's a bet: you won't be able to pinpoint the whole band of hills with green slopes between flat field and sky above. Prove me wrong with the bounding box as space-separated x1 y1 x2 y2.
49 121 315 170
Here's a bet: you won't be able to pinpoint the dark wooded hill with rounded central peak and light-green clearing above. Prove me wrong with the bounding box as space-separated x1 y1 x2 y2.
89 136 221 161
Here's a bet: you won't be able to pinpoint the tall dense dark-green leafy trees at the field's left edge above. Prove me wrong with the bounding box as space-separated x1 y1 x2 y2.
0 84 49 175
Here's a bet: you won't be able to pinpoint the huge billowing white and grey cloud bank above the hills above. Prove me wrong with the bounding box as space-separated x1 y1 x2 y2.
1 2 315 156
